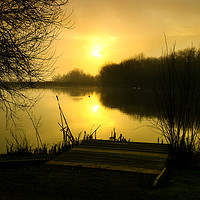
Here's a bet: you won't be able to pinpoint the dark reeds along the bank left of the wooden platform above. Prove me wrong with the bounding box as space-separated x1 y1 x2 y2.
6 96 101 156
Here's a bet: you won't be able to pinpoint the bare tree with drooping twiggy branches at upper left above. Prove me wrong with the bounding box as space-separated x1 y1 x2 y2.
0 0 71 114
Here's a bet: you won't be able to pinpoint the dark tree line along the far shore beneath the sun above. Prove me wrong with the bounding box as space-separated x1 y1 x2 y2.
52 47 200 89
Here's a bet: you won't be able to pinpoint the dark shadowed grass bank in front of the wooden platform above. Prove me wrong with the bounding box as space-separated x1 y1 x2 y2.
0 164 200 200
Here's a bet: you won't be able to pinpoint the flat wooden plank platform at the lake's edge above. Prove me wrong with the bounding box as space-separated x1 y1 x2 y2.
47 140 168 174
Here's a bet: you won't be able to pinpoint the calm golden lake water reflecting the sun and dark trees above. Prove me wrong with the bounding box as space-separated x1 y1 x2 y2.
0 87 160 153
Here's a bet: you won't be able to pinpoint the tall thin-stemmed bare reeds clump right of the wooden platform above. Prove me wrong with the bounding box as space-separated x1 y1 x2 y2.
155 38 200 167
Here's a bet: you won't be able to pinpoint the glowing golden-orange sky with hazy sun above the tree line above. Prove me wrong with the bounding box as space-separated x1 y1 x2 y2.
54 0 200 75
